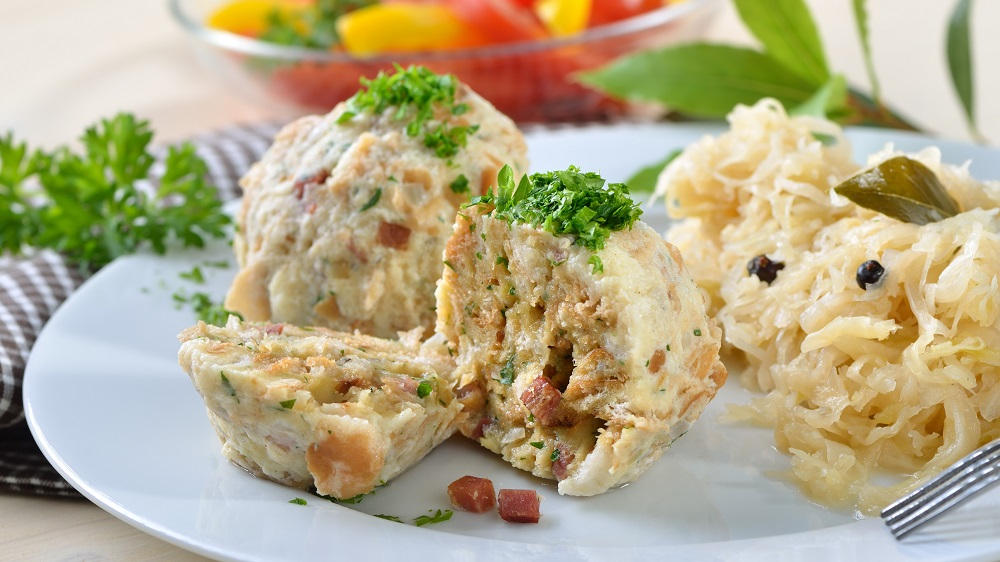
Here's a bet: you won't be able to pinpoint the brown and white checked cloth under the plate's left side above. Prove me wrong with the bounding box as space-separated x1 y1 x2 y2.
0 119 278 497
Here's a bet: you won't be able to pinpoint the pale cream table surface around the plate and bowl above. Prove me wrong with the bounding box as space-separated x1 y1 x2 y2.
0 0 1000 560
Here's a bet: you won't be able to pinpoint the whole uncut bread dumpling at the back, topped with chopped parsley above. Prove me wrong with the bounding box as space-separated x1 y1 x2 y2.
226 67 527 337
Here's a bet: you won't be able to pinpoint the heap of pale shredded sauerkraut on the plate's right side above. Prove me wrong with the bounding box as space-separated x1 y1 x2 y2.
657 100 1000 513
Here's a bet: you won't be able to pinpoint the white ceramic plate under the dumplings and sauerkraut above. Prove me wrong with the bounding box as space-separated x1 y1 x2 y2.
24 125 1000 562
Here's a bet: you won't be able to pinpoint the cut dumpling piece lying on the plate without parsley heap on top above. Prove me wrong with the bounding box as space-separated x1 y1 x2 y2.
179 317 461 498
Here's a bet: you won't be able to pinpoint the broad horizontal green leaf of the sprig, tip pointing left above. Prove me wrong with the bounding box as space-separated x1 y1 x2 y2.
579 45 822 117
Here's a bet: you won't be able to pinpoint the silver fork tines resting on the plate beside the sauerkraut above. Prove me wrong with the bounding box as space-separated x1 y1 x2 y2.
882 439 1000 540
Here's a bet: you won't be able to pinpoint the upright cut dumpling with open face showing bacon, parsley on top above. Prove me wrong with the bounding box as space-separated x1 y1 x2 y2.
437 167 726 496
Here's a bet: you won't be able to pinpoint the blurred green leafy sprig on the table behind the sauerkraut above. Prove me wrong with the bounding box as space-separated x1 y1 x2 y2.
579 0 981 138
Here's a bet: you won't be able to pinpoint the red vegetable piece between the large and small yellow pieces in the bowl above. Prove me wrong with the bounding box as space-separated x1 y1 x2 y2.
446 0 547 43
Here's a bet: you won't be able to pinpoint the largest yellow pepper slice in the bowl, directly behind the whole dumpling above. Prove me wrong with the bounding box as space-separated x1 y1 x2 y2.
337 4 475 55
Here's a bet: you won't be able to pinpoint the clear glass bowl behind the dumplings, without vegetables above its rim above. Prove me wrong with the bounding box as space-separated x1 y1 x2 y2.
169 0 719 123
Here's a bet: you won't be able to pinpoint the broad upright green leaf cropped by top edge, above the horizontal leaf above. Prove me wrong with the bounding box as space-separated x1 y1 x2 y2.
733 0 830 86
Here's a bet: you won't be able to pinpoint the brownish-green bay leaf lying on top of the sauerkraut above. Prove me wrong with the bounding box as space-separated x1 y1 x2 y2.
835 156 960 224
